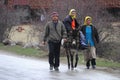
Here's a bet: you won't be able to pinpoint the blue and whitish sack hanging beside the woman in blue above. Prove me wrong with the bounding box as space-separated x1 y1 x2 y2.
79 31 88 50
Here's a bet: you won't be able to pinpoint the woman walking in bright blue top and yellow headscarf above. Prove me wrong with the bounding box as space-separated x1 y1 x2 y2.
81 16 99 69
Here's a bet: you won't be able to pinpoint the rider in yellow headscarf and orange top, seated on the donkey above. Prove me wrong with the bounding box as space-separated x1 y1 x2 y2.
63 9 79 38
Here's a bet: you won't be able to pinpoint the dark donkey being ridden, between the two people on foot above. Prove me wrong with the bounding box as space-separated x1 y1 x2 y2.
64 33 79 70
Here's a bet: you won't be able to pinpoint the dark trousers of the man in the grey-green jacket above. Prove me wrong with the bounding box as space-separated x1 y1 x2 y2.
48 42 61 67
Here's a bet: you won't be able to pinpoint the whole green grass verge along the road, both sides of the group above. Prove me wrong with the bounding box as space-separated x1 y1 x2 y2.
0 43 120 69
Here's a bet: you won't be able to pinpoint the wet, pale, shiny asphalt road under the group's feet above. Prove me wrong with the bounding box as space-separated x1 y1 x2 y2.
0 51 120 80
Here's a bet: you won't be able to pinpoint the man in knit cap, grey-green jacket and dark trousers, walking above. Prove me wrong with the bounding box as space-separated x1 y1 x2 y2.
42 12 67 71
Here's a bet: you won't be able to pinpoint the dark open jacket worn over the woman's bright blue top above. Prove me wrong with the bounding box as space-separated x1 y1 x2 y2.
81 25 99 43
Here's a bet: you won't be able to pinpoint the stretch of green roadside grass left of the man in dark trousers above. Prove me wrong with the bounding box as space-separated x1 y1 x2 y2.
0 43 47 58
